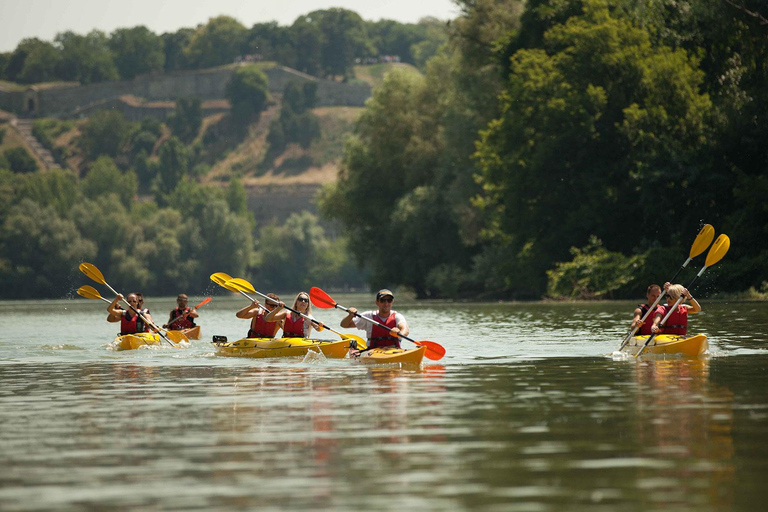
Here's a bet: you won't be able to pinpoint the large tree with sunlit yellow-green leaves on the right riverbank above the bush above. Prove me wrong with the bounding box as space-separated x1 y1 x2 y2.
476 1 711 297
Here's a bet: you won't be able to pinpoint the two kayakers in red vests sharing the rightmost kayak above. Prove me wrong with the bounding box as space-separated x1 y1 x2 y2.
631 283 701 336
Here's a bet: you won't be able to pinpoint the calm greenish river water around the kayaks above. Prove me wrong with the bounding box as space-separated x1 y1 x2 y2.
0 294 768 512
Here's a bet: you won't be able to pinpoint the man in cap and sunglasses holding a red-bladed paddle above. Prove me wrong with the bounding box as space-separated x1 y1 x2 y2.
341 288 409 348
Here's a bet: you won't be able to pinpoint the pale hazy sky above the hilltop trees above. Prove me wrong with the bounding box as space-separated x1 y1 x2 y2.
0 0 458 52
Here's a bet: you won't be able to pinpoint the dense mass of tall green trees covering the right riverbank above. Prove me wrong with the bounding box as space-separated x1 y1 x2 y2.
322 0 768 298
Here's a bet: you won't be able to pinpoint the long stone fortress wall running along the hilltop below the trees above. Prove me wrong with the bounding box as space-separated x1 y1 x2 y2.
0 65 371 117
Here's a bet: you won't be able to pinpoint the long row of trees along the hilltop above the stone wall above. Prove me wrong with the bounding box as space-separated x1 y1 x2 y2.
0 8 445 84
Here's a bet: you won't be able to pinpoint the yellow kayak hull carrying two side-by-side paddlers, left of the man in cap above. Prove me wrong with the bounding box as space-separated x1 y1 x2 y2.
213 338 349 359
